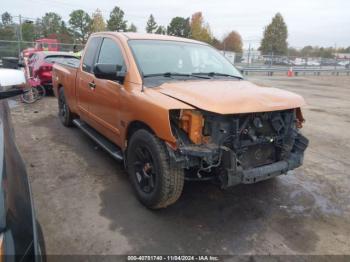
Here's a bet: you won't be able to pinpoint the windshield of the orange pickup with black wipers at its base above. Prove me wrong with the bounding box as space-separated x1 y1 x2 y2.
129 40 242 77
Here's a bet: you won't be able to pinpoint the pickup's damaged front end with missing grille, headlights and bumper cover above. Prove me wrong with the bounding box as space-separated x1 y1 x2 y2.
169 108 308 188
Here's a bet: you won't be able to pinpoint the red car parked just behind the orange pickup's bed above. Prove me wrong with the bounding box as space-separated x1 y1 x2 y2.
27 51 79 89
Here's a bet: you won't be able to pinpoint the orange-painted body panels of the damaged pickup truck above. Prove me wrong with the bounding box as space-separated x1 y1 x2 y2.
52 32 305 150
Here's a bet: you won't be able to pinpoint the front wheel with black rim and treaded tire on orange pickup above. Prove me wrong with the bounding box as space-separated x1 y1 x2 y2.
127 129 184 209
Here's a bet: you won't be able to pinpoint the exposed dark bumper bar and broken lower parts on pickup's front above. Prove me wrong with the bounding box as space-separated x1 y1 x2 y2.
169 109 309 188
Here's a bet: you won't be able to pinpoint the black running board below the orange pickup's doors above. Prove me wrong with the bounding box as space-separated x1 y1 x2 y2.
73 119 123 161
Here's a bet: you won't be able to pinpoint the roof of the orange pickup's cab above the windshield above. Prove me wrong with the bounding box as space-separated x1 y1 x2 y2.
89 32 206 45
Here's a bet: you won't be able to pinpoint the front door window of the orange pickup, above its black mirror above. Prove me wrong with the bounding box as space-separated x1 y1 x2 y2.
98 38 125 68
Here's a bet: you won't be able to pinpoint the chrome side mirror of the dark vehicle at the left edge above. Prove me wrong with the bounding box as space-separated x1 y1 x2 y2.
0 69 26 99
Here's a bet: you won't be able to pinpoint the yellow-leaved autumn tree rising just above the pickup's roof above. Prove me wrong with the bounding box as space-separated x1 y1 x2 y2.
191 12 213 44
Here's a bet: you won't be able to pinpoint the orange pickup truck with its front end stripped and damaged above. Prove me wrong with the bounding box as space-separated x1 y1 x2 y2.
52 32 308 209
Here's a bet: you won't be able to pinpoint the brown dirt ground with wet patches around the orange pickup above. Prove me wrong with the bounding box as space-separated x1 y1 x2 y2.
12 76 350 254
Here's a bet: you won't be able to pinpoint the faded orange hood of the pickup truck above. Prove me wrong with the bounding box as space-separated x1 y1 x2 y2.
155 80 305 114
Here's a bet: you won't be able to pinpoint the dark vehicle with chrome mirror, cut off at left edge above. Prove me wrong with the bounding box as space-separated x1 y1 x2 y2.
0 69 45 261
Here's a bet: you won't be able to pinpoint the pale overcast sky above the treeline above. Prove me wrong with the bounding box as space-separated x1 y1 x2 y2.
0 0 350 49
